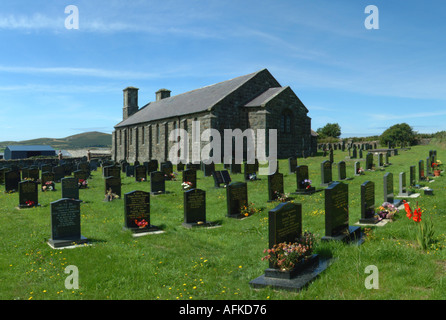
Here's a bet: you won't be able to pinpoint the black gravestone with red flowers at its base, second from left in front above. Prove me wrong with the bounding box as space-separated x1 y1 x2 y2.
124 190 159 234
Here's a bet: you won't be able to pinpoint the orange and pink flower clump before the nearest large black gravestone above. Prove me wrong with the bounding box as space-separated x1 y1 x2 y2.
261 232 315 271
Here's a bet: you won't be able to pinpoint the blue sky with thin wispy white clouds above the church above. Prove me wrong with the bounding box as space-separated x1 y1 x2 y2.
0 0 446 141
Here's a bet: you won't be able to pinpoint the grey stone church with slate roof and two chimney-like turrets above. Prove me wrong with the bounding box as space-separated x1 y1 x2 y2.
112 69 317 162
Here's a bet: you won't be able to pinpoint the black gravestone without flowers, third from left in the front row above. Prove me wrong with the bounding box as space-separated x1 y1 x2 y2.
183 190 210 228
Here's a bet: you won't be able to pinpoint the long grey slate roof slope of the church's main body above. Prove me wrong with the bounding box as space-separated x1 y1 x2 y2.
115 69 276 128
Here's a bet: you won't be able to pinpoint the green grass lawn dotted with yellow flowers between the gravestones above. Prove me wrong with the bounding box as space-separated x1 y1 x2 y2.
0 145 446 300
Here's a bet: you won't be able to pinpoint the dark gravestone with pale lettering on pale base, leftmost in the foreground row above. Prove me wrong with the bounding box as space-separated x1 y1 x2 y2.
48 199 88 248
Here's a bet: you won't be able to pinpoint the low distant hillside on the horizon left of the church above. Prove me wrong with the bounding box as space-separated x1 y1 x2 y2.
0 131 112 150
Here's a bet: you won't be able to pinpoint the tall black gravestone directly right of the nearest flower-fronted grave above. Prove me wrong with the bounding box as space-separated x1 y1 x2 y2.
322 182 361 242
